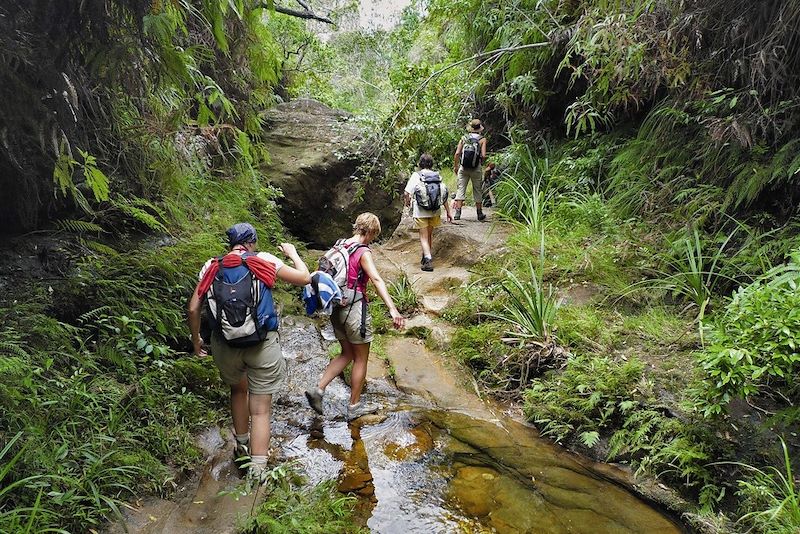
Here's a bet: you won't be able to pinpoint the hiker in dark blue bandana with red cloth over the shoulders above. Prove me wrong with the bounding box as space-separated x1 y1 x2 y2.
188 223 310 482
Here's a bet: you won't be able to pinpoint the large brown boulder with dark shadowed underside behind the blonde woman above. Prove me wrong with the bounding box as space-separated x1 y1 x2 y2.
265 99 402 247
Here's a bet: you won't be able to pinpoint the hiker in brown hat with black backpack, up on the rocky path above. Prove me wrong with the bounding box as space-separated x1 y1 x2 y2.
453 119 486 221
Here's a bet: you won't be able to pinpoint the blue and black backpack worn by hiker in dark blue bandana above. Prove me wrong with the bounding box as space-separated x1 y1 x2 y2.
206 252 279 347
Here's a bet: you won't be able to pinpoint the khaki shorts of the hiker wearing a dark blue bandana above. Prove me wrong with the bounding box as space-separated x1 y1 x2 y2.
211 332 286 395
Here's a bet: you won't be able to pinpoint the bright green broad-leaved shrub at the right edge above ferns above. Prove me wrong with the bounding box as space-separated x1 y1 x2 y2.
699 253 800 416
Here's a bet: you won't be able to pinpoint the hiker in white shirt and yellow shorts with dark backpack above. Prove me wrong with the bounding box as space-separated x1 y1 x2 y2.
403 154 453 272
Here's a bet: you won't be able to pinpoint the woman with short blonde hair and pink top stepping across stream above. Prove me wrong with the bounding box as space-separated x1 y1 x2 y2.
305 213 405 421
